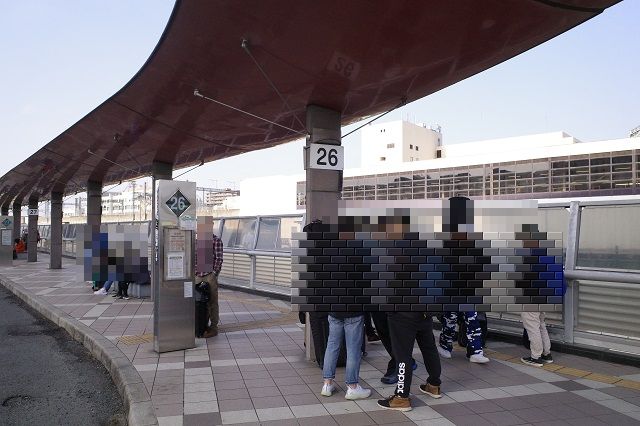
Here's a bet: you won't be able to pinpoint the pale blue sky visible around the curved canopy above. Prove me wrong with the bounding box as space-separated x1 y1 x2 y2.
0 0 640 191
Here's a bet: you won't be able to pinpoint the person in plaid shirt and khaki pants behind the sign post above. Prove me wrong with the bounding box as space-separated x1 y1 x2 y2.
195 216 224 339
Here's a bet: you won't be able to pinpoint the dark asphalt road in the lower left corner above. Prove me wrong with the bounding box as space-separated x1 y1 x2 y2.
0 285 126 426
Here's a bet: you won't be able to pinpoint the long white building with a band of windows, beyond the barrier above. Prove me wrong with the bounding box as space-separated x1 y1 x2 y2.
232 121 640 215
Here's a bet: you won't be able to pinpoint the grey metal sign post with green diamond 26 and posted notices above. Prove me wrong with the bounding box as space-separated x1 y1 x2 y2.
153 180 196 352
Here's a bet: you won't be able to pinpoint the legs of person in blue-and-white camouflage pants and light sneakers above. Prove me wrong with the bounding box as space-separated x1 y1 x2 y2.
438 312 489 364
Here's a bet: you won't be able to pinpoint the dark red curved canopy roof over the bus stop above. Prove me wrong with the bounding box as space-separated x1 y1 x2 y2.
0 0 618 206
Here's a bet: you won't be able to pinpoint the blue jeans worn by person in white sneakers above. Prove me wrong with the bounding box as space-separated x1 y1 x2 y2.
322 315 364 385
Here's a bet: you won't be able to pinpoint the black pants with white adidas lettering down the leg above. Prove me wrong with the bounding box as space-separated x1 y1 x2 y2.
389 312 442 398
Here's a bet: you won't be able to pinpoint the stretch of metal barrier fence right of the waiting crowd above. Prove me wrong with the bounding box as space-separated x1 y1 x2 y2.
489 200 640 355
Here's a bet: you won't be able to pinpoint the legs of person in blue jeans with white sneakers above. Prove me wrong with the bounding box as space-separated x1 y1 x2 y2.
320 312 371 399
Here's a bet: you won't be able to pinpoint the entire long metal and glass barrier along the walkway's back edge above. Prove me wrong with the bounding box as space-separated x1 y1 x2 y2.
27 203 640 354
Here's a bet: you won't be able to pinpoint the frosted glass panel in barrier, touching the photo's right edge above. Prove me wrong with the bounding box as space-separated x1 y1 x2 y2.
577 205 640 271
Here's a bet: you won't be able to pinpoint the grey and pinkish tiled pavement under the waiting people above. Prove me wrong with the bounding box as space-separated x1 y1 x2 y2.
0 255 640 426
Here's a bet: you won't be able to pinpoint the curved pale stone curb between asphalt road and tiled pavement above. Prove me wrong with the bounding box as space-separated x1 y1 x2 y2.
0 276 158 426
